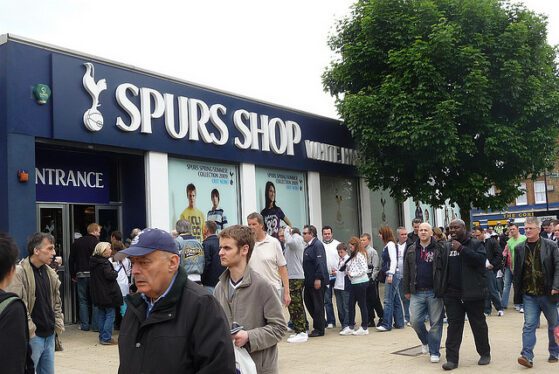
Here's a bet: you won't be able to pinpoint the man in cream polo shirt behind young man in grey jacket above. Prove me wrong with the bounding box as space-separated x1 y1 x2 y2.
247 212 291 306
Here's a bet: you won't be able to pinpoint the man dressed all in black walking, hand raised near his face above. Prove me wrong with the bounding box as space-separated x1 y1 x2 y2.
434 219 491 370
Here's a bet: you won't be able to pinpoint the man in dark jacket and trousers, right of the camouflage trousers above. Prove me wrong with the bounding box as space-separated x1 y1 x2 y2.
303 225 329 338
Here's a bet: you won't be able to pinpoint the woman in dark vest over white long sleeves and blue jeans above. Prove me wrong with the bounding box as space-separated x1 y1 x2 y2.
377 226 404 331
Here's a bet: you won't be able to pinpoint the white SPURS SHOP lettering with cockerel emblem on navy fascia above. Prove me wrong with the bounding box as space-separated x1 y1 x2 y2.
82 62 356 165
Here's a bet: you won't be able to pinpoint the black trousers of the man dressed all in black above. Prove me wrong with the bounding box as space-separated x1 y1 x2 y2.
444 297 491 364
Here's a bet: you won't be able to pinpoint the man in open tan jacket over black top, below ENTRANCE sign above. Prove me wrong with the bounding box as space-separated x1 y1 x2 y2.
7 232 64 374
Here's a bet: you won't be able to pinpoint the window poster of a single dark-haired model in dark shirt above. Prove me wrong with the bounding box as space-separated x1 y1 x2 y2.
256 168 308 237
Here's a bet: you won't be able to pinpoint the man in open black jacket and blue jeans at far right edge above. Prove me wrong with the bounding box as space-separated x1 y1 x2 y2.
513 217 559 368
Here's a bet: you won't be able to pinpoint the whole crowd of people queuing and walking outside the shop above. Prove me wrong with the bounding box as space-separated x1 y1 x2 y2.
0 212 559 373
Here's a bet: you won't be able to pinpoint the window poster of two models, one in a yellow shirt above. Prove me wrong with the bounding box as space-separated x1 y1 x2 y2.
169 158 240 241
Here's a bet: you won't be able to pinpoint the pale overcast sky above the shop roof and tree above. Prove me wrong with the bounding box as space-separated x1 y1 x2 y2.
0 0 559 118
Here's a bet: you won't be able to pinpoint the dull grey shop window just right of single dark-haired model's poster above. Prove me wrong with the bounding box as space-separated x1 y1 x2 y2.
317 175 361 242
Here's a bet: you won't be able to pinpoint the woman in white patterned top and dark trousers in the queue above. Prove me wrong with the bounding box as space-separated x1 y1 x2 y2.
345 236 369 335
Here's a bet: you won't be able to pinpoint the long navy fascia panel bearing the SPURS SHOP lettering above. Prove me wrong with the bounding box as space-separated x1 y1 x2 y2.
52 54 357 174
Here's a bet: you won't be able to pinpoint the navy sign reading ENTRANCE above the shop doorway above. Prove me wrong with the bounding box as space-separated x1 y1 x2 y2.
35 151 110 204
